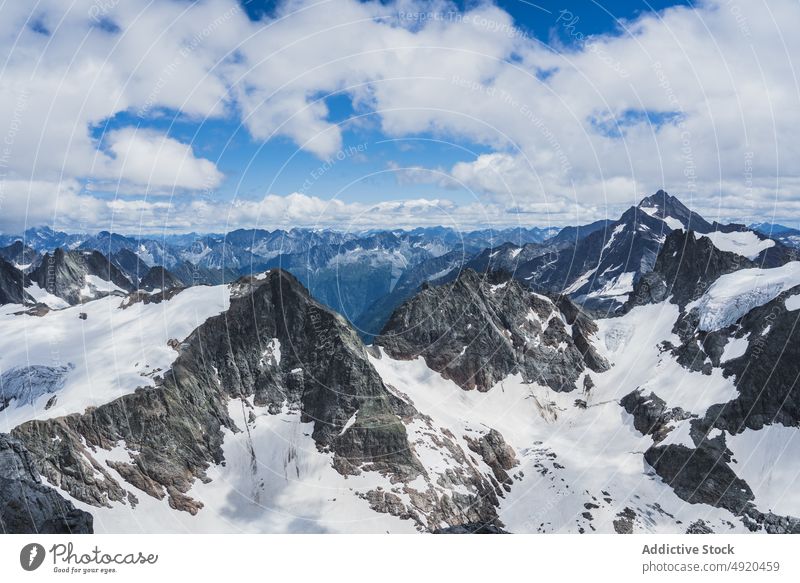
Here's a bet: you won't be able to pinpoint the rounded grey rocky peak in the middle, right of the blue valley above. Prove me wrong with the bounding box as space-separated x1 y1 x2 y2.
376 269 608 391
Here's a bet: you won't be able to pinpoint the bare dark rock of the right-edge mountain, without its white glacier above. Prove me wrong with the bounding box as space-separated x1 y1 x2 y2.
621 230 800 532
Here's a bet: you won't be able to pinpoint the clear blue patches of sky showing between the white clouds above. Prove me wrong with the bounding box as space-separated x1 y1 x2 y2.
90 0 686 214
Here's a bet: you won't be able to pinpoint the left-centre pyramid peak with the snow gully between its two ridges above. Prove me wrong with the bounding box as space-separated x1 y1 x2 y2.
13 270 513 530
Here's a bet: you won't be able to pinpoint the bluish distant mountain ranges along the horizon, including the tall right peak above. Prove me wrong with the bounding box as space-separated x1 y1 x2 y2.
0 191 800 341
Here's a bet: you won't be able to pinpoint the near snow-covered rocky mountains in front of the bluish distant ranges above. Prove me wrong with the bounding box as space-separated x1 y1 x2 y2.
0 219 800 533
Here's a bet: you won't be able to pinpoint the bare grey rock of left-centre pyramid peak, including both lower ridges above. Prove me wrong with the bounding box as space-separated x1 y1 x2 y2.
13 270 506 529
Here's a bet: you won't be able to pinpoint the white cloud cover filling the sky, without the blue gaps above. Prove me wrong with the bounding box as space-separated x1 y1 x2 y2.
0 0 800 233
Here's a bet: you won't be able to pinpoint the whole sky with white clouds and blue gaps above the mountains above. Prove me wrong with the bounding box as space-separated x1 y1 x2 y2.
0 0 800 232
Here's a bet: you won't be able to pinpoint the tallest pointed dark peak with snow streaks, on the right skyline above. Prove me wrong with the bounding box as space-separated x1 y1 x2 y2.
450 190 794 316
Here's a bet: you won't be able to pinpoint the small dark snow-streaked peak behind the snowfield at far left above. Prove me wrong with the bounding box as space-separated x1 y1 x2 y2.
29 248 133 305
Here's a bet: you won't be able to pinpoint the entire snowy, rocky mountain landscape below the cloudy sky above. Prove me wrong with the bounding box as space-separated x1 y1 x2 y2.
0 191 800 533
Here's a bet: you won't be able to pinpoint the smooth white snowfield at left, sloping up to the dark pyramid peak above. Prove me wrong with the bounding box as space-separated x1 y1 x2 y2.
0 286 230 432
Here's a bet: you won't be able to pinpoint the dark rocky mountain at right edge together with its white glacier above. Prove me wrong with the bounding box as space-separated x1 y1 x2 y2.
622 236 800 532
